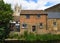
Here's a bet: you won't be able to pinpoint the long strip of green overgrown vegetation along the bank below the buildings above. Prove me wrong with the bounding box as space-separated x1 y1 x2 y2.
9 32 60 41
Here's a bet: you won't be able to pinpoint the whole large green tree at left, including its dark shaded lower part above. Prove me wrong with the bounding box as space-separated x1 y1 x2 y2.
0 0 13 39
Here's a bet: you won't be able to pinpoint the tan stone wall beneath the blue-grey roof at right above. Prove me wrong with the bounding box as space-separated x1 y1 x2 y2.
48 19 60 33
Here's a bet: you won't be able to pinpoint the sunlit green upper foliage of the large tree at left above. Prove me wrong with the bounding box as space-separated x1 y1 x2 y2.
0 1 13 25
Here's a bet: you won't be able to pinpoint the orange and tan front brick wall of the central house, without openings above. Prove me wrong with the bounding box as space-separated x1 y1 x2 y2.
20 15 47 33
